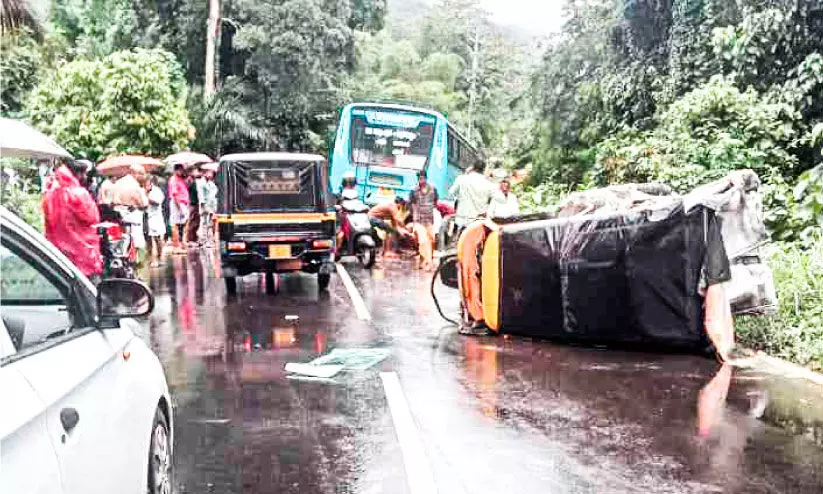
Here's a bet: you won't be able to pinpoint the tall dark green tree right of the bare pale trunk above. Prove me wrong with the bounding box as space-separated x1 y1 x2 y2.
190 0 385 152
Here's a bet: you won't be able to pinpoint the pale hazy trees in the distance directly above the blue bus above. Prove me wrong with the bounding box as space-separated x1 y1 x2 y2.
347 0 530 155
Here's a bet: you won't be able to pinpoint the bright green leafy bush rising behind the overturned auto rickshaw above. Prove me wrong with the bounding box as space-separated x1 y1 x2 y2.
595 77 797 188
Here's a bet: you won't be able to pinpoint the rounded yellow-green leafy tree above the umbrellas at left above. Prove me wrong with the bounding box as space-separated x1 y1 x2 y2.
26 49 190 160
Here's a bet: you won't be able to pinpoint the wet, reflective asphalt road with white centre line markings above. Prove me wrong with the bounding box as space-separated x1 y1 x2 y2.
138 256 823 494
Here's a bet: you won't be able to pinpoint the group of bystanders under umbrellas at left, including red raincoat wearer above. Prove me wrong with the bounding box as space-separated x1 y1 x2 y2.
42 160 217 279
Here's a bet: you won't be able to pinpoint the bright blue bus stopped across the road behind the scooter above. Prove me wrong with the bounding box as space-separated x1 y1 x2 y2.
330 103 481 204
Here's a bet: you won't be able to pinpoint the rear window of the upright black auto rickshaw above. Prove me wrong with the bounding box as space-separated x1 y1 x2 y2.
231 161 319 211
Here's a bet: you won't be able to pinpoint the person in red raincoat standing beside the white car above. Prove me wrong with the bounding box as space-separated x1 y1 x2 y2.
43 163 103 278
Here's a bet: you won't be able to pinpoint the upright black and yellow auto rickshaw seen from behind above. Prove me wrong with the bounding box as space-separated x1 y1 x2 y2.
216 153 336 295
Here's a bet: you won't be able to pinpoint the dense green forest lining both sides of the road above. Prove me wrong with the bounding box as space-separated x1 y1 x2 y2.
0 0 823 367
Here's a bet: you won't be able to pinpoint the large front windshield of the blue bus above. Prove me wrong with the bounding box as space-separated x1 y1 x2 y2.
351 108 434 170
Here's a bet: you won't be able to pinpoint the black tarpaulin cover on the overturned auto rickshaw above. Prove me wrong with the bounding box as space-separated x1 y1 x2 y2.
499 205 729 349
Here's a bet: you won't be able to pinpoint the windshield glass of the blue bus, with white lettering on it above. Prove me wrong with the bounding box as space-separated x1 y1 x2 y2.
351 112 434 170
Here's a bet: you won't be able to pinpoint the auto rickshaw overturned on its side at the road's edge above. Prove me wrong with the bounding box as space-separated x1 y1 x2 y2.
440 170 777 358
